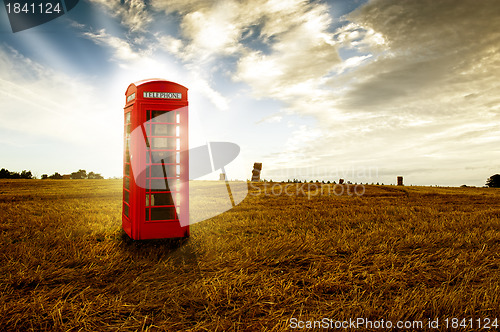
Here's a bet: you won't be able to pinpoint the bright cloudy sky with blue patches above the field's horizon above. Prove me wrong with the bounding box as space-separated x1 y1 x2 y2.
0 0 500 186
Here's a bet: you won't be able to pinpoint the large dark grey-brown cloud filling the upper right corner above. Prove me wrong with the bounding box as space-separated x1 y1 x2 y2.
330 0 500 114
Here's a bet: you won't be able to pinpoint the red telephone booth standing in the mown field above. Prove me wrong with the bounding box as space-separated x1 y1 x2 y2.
122 79 189 240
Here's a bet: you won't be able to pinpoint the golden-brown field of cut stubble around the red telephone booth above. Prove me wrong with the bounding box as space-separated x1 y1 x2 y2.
0 180 500 331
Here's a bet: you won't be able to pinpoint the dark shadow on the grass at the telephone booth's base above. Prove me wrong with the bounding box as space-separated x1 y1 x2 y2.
120 230 201 276
